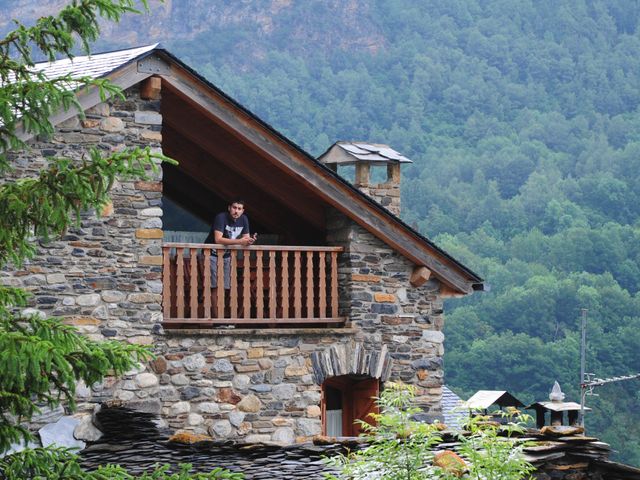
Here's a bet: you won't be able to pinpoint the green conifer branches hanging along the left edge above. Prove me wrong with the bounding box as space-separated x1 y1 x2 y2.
0 0 168 456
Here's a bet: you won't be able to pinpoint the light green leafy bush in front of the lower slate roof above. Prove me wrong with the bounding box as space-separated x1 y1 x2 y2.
325 383 533 480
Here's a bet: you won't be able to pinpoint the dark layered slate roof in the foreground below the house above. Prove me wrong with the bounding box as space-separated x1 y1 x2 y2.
79 404 640 480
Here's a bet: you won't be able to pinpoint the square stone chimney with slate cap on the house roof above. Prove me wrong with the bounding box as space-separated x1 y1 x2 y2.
318 142 411 216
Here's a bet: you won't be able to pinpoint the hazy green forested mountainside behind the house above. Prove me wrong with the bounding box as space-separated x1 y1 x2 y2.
5 0 640 465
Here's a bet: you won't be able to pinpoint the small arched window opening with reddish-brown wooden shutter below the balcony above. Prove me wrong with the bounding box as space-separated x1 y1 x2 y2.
322 375 380 437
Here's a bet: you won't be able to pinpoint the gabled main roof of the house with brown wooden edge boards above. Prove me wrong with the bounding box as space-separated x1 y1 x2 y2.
32 44 484 293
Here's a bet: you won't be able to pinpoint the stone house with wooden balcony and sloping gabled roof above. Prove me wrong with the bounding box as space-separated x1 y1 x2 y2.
5 46 483 443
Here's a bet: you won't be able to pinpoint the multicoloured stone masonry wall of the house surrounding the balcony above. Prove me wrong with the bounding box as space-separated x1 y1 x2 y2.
0 81 443 443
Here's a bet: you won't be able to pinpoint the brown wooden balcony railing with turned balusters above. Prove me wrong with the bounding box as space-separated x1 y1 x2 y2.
162 243 345 327
